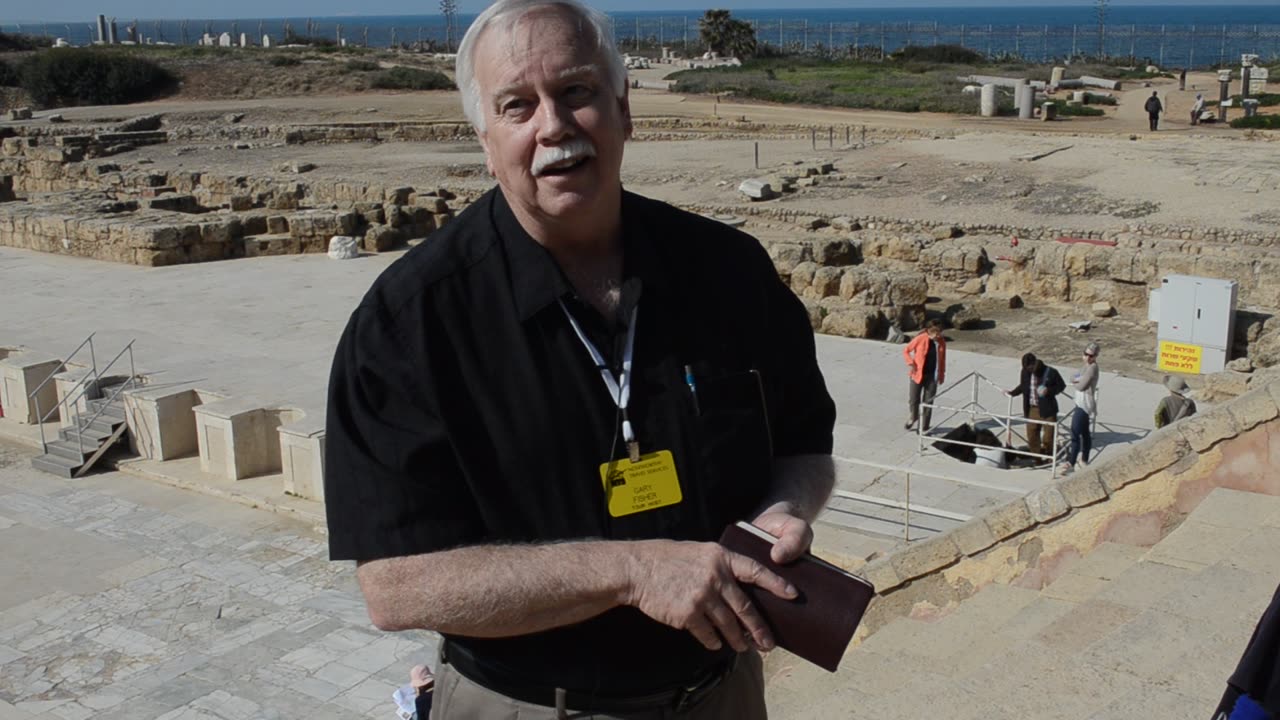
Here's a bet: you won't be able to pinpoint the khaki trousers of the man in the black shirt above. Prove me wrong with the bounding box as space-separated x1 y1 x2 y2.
431 651 768 720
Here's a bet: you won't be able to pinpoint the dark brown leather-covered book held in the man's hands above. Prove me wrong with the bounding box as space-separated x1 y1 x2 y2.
719 523 876 673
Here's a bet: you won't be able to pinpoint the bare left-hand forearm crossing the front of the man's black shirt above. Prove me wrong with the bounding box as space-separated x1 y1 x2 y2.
356 541 628 637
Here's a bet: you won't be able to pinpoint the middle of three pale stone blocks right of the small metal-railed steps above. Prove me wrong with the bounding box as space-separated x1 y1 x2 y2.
193 398 301 480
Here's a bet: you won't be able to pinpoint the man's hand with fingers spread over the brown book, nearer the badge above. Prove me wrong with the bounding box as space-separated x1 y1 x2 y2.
623 541 796 652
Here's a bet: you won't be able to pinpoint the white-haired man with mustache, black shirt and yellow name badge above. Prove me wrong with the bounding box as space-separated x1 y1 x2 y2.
325 0 835 719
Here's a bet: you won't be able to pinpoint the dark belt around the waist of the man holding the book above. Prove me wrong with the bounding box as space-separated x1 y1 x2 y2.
440 639 737 714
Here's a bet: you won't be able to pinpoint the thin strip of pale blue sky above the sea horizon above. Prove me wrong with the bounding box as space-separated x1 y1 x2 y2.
0 0 1276 23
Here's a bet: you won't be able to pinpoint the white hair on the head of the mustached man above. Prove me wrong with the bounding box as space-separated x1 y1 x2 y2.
454 0 627 133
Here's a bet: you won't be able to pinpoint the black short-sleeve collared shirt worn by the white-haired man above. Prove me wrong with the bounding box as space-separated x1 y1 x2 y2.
325 190 835 693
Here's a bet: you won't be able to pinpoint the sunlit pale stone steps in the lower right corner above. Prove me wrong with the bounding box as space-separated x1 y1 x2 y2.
765 488 1280 720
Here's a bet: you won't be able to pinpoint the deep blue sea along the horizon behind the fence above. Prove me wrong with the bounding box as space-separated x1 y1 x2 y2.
0 3 1280 68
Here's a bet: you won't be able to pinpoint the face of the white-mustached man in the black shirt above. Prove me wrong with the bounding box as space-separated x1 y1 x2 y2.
475 8 631 220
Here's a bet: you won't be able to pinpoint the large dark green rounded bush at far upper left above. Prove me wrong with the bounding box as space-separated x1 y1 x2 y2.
19 47 178 108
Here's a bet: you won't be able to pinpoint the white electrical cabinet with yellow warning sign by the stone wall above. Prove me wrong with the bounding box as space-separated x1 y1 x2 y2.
1151 275 1239 374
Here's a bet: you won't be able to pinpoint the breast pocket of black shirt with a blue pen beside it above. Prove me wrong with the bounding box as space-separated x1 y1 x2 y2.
698 370 773 521
